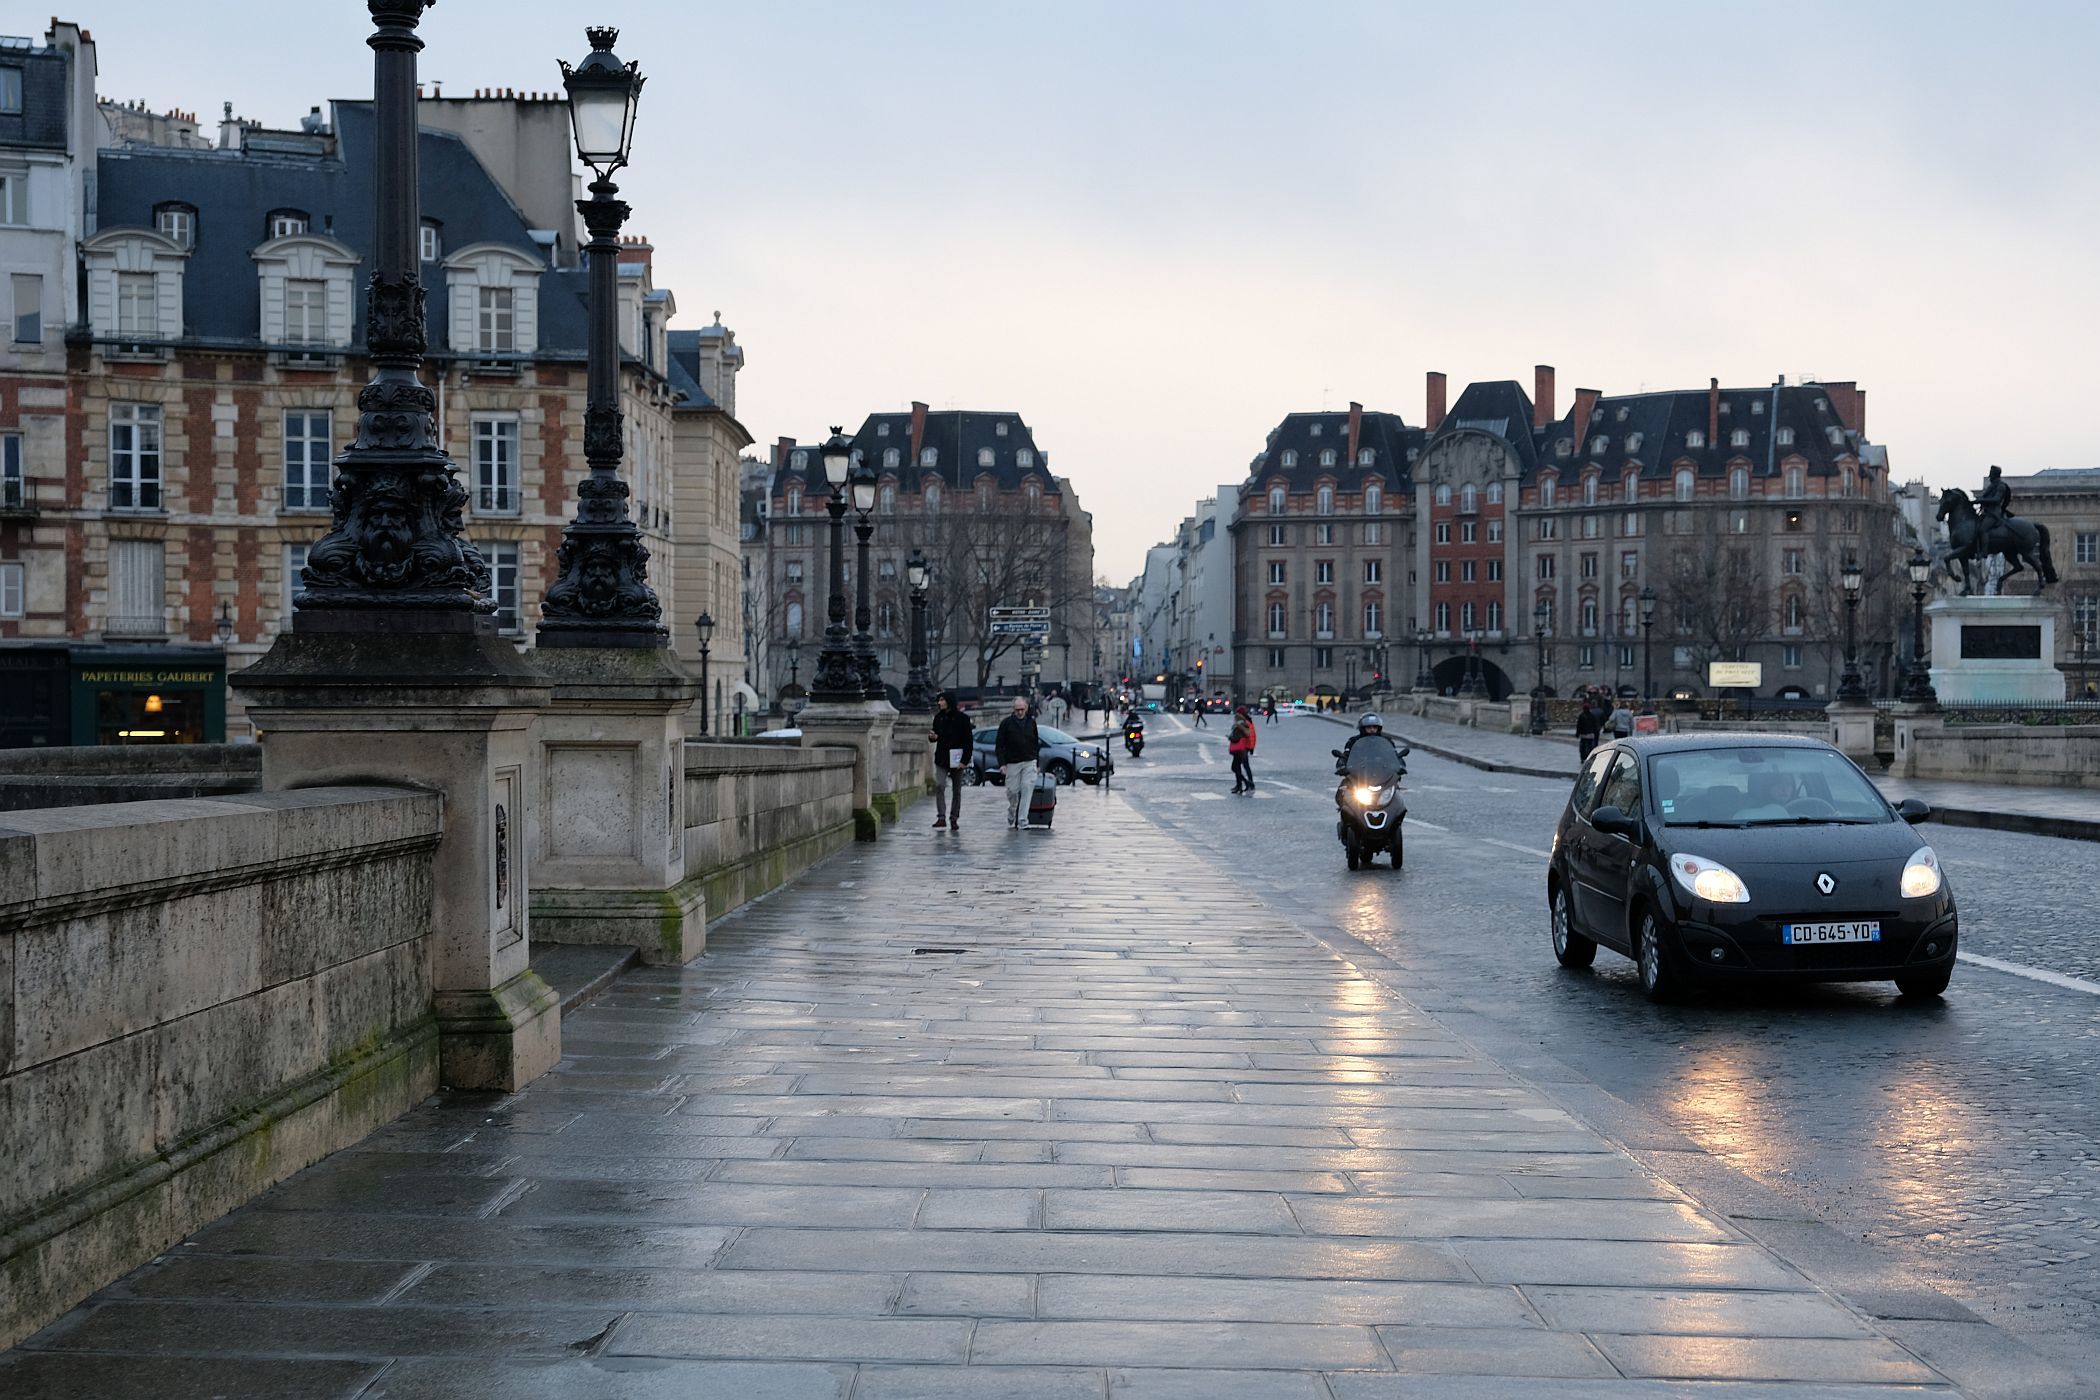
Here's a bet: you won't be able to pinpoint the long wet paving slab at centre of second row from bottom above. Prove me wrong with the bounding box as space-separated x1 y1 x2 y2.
970 1322 1386 1371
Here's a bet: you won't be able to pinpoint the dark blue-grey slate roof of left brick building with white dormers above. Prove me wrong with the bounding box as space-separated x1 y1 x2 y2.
97 101 586 359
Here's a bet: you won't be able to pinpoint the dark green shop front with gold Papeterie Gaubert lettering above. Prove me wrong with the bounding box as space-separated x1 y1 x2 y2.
0 642 227 747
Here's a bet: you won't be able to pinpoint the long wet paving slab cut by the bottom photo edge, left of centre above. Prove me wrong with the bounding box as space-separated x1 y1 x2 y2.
361 1356 855 1400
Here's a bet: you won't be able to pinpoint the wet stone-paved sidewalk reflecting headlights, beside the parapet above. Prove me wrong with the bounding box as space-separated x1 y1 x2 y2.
0 791 2075 1400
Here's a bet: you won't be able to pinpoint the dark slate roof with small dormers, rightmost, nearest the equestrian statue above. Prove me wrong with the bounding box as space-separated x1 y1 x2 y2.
1525 384 1863 481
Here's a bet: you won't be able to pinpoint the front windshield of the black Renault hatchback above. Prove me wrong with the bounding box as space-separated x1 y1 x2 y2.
1651 745 1894 827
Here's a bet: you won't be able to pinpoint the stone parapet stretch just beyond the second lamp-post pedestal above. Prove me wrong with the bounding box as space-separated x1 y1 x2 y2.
685 741 853 919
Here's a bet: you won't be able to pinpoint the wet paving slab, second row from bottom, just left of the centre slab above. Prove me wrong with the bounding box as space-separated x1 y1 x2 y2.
605 1312 972 1364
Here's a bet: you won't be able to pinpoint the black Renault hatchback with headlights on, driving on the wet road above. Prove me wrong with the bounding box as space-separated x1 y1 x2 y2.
1546 735 1957 1001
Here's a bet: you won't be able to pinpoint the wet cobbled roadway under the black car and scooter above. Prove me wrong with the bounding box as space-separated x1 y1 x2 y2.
1117 718 2100 1394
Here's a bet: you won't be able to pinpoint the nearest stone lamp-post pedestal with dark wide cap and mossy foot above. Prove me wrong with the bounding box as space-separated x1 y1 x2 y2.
231 615 561 1091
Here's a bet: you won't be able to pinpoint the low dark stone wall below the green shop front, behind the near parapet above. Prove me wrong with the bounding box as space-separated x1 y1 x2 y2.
0 743 263 812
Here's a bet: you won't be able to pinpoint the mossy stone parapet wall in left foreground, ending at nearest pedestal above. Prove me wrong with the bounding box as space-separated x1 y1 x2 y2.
0 787 443 1345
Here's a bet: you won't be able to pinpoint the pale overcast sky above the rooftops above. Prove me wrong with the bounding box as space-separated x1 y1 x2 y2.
74 0 2100 581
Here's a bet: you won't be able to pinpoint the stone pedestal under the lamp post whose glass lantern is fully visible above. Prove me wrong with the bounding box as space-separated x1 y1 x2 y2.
525 646 708 963
